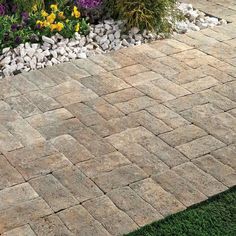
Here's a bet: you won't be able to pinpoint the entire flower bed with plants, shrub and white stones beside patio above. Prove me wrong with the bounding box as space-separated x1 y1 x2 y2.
0 0 226 78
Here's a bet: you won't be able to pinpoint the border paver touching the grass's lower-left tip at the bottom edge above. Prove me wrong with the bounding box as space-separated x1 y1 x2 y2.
83 196 138 235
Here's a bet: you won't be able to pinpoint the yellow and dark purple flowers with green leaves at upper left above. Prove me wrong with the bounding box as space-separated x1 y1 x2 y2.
0 2 89 50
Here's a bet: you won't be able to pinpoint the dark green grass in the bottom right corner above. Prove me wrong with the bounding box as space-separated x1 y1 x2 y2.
128 187 236 236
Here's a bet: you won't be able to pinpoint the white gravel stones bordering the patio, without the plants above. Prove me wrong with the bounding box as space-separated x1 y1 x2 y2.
0 3 227 79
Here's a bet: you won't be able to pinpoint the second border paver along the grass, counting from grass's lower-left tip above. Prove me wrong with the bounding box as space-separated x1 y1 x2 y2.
107 187 162 226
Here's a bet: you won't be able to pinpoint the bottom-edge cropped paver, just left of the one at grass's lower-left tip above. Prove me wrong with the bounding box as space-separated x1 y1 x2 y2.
57 206 110 236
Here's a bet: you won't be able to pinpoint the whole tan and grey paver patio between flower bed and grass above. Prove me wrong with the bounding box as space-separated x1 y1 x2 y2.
0 0 236 236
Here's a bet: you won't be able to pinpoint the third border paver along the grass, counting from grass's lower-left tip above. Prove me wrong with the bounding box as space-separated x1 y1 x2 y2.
130 178 185 216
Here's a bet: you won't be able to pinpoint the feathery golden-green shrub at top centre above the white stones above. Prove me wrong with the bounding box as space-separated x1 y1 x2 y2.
116 0 179 33
